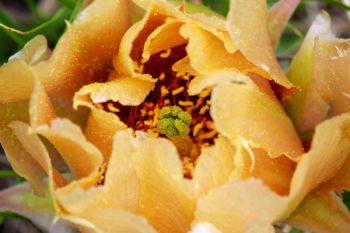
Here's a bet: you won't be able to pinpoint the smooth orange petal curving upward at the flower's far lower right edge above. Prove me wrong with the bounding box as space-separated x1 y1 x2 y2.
287 113 350 218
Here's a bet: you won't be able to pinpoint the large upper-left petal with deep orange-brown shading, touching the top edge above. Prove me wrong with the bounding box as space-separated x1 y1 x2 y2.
34 0 130 95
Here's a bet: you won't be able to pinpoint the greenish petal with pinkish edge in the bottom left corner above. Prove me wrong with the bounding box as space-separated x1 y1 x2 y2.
0 183 76 233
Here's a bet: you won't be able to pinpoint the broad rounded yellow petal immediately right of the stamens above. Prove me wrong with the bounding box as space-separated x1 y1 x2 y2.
211 72 303 159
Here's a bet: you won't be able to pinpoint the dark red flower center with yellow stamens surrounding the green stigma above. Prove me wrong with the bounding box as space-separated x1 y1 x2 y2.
103 44 218 176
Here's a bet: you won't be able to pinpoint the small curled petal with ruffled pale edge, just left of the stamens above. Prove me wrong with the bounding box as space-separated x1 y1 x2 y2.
74 73 154 107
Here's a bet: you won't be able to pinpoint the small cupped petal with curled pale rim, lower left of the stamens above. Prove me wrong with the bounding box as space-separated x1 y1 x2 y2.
35 118 103 178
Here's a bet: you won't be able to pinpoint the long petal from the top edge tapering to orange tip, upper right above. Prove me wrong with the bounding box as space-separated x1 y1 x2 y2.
227 0 295 94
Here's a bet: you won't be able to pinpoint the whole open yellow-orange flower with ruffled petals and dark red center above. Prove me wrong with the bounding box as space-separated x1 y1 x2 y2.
0 0 350 232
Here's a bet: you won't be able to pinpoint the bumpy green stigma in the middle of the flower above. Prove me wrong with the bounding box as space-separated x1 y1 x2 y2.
157 106 192 138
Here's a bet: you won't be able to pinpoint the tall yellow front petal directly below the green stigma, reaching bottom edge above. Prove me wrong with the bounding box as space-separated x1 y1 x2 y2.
134 134 195 232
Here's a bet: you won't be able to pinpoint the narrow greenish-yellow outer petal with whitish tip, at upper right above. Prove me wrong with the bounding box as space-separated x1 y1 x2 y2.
285 12 333 134
